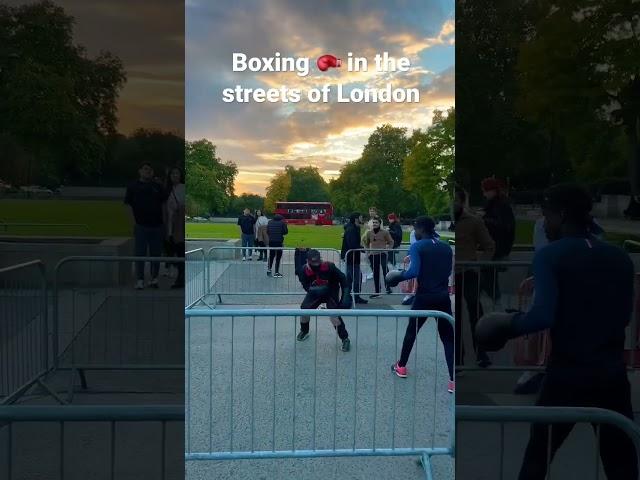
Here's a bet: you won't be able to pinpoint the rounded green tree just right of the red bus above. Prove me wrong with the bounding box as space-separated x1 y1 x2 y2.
330 125 423 217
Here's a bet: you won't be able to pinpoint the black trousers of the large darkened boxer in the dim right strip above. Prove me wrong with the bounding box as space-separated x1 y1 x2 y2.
518 371 638 480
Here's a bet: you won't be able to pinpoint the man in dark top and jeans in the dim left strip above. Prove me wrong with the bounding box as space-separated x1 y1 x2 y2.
124 162 167 290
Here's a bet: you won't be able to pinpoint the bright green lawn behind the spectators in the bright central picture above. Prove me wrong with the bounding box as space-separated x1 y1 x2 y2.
187 223 409 250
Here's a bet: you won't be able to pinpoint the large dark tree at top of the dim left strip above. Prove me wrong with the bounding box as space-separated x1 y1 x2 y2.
0 1 125 185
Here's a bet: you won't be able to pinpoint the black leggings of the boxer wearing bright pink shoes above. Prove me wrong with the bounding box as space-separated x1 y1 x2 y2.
398 294 455 380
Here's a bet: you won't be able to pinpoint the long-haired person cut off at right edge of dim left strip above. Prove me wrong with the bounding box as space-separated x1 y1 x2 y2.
165 167 185 288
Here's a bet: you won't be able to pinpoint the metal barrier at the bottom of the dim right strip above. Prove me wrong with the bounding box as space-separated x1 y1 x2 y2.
455 405 640 480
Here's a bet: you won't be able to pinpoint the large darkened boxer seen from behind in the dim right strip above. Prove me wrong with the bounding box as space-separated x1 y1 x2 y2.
476 184 638 480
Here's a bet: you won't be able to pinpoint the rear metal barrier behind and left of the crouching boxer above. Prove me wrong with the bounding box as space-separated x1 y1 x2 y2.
206 247 341 305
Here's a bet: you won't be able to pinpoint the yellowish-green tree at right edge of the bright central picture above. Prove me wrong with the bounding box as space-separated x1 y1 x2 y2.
404 108 456 215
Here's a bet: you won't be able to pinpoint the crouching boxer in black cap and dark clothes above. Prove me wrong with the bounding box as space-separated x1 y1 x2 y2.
296 250 351 352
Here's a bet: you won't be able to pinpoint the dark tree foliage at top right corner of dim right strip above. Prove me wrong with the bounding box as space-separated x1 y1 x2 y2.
518 0 640 212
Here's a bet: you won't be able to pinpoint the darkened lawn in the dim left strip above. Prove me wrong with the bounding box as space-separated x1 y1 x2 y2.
0 199 132 237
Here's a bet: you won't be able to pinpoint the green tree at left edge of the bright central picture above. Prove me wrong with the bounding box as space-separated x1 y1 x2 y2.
184 139 238 216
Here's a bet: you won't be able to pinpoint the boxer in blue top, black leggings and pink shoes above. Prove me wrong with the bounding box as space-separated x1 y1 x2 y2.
386 216 455 393
